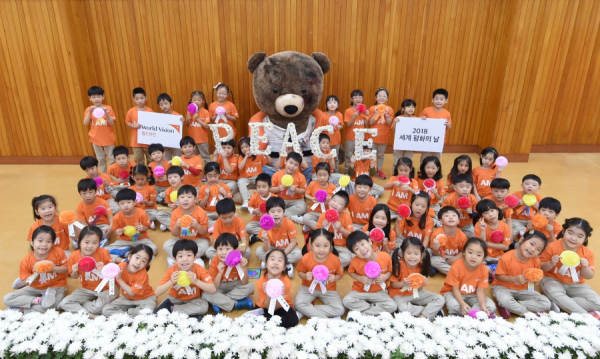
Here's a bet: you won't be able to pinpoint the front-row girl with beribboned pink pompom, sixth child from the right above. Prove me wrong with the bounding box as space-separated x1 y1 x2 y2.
295 228 346 318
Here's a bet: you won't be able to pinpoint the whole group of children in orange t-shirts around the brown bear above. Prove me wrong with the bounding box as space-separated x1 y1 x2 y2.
4 85 600 327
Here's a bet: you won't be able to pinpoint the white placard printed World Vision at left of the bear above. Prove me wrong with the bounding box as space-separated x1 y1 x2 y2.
138 111 183 148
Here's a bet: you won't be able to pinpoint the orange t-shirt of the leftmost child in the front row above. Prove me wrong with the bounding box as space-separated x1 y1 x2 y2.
19 246 67 289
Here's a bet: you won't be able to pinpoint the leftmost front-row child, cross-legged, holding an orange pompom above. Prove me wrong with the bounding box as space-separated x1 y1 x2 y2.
4 225 67 314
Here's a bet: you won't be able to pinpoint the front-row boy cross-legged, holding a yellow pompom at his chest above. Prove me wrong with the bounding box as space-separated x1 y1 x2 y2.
154 240 217 321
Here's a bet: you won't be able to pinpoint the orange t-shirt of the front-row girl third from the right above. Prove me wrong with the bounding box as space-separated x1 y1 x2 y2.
440 258 489 295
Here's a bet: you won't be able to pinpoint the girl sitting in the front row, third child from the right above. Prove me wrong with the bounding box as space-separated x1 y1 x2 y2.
440 238 496 317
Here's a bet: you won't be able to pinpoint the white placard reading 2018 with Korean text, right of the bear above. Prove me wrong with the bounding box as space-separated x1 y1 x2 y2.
394 117 446 152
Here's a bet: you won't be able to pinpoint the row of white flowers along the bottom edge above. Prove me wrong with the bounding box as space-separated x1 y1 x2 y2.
0 310 600 359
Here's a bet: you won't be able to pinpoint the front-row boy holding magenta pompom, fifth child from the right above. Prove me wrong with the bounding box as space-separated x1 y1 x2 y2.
342 232 398 320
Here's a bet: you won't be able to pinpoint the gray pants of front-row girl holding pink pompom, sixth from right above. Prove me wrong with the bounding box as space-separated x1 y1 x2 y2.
294 285 346 318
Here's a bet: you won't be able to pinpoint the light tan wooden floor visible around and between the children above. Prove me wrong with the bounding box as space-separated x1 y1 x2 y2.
0 153 600 320
